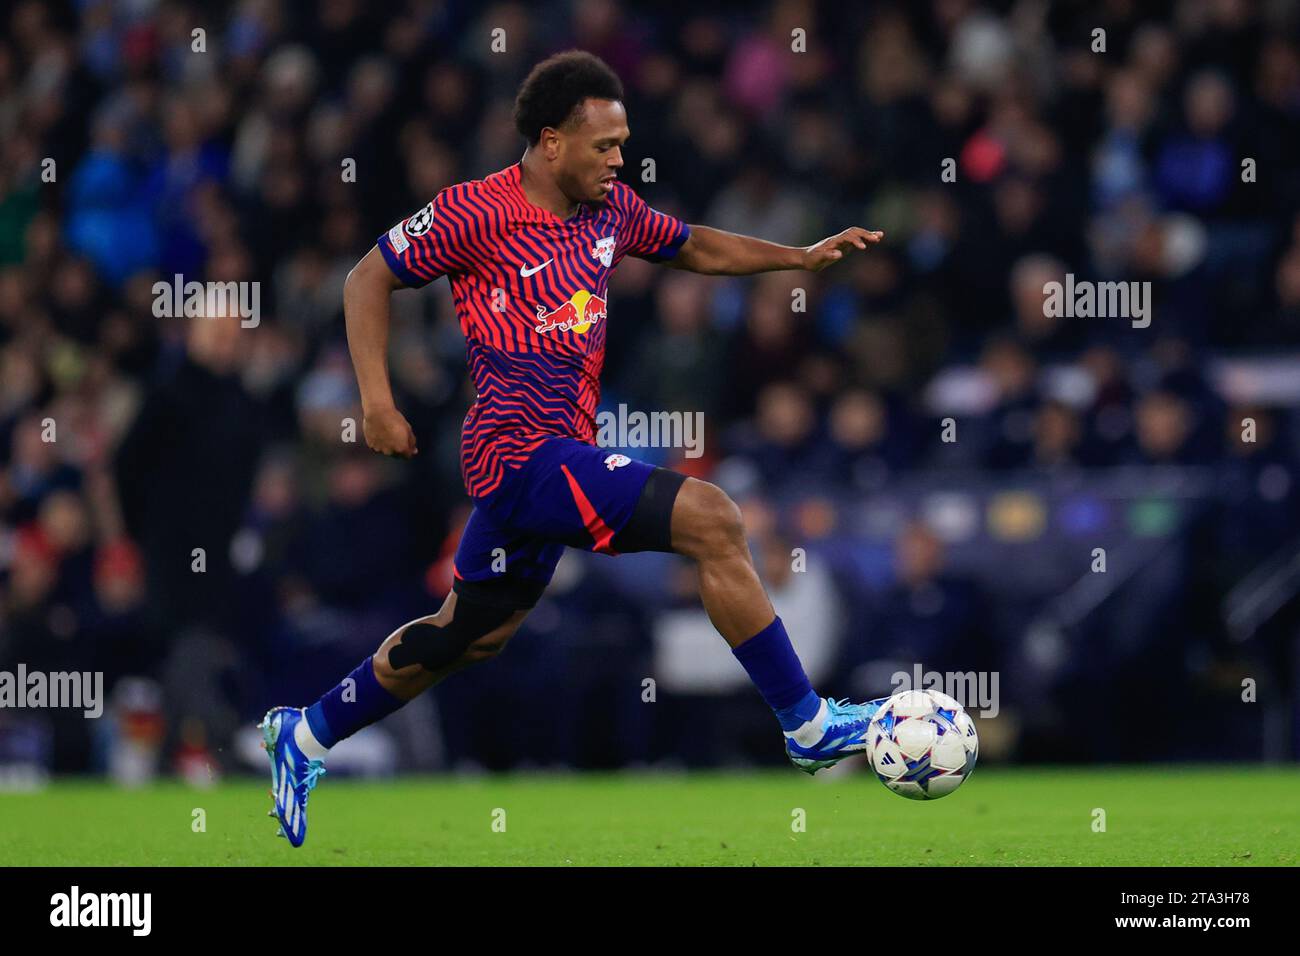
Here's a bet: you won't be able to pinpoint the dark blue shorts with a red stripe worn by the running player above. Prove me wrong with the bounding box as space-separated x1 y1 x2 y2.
452 437 685 607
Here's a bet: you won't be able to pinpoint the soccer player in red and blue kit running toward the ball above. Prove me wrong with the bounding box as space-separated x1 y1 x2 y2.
260 51 881 847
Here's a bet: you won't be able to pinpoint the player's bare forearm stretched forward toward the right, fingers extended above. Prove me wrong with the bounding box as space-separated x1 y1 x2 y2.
666 225 884 276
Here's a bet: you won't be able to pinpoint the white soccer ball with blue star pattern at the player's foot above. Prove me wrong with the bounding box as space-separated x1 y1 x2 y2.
867 691 979 800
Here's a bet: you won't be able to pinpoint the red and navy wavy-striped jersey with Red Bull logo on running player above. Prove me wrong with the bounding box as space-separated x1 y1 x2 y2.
378 163 690 497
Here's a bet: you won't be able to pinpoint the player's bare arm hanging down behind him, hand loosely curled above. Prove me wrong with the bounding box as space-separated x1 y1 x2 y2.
343 246 419 458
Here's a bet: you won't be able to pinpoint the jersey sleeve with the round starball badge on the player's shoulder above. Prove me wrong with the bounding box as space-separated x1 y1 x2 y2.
376 189 484 289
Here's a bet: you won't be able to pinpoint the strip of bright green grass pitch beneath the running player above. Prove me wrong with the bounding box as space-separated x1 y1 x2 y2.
0 763 1300 866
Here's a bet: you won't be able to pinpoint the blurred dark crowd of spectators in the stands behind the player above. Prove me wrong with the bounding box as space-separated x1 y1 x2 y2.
0 0 1300 780
